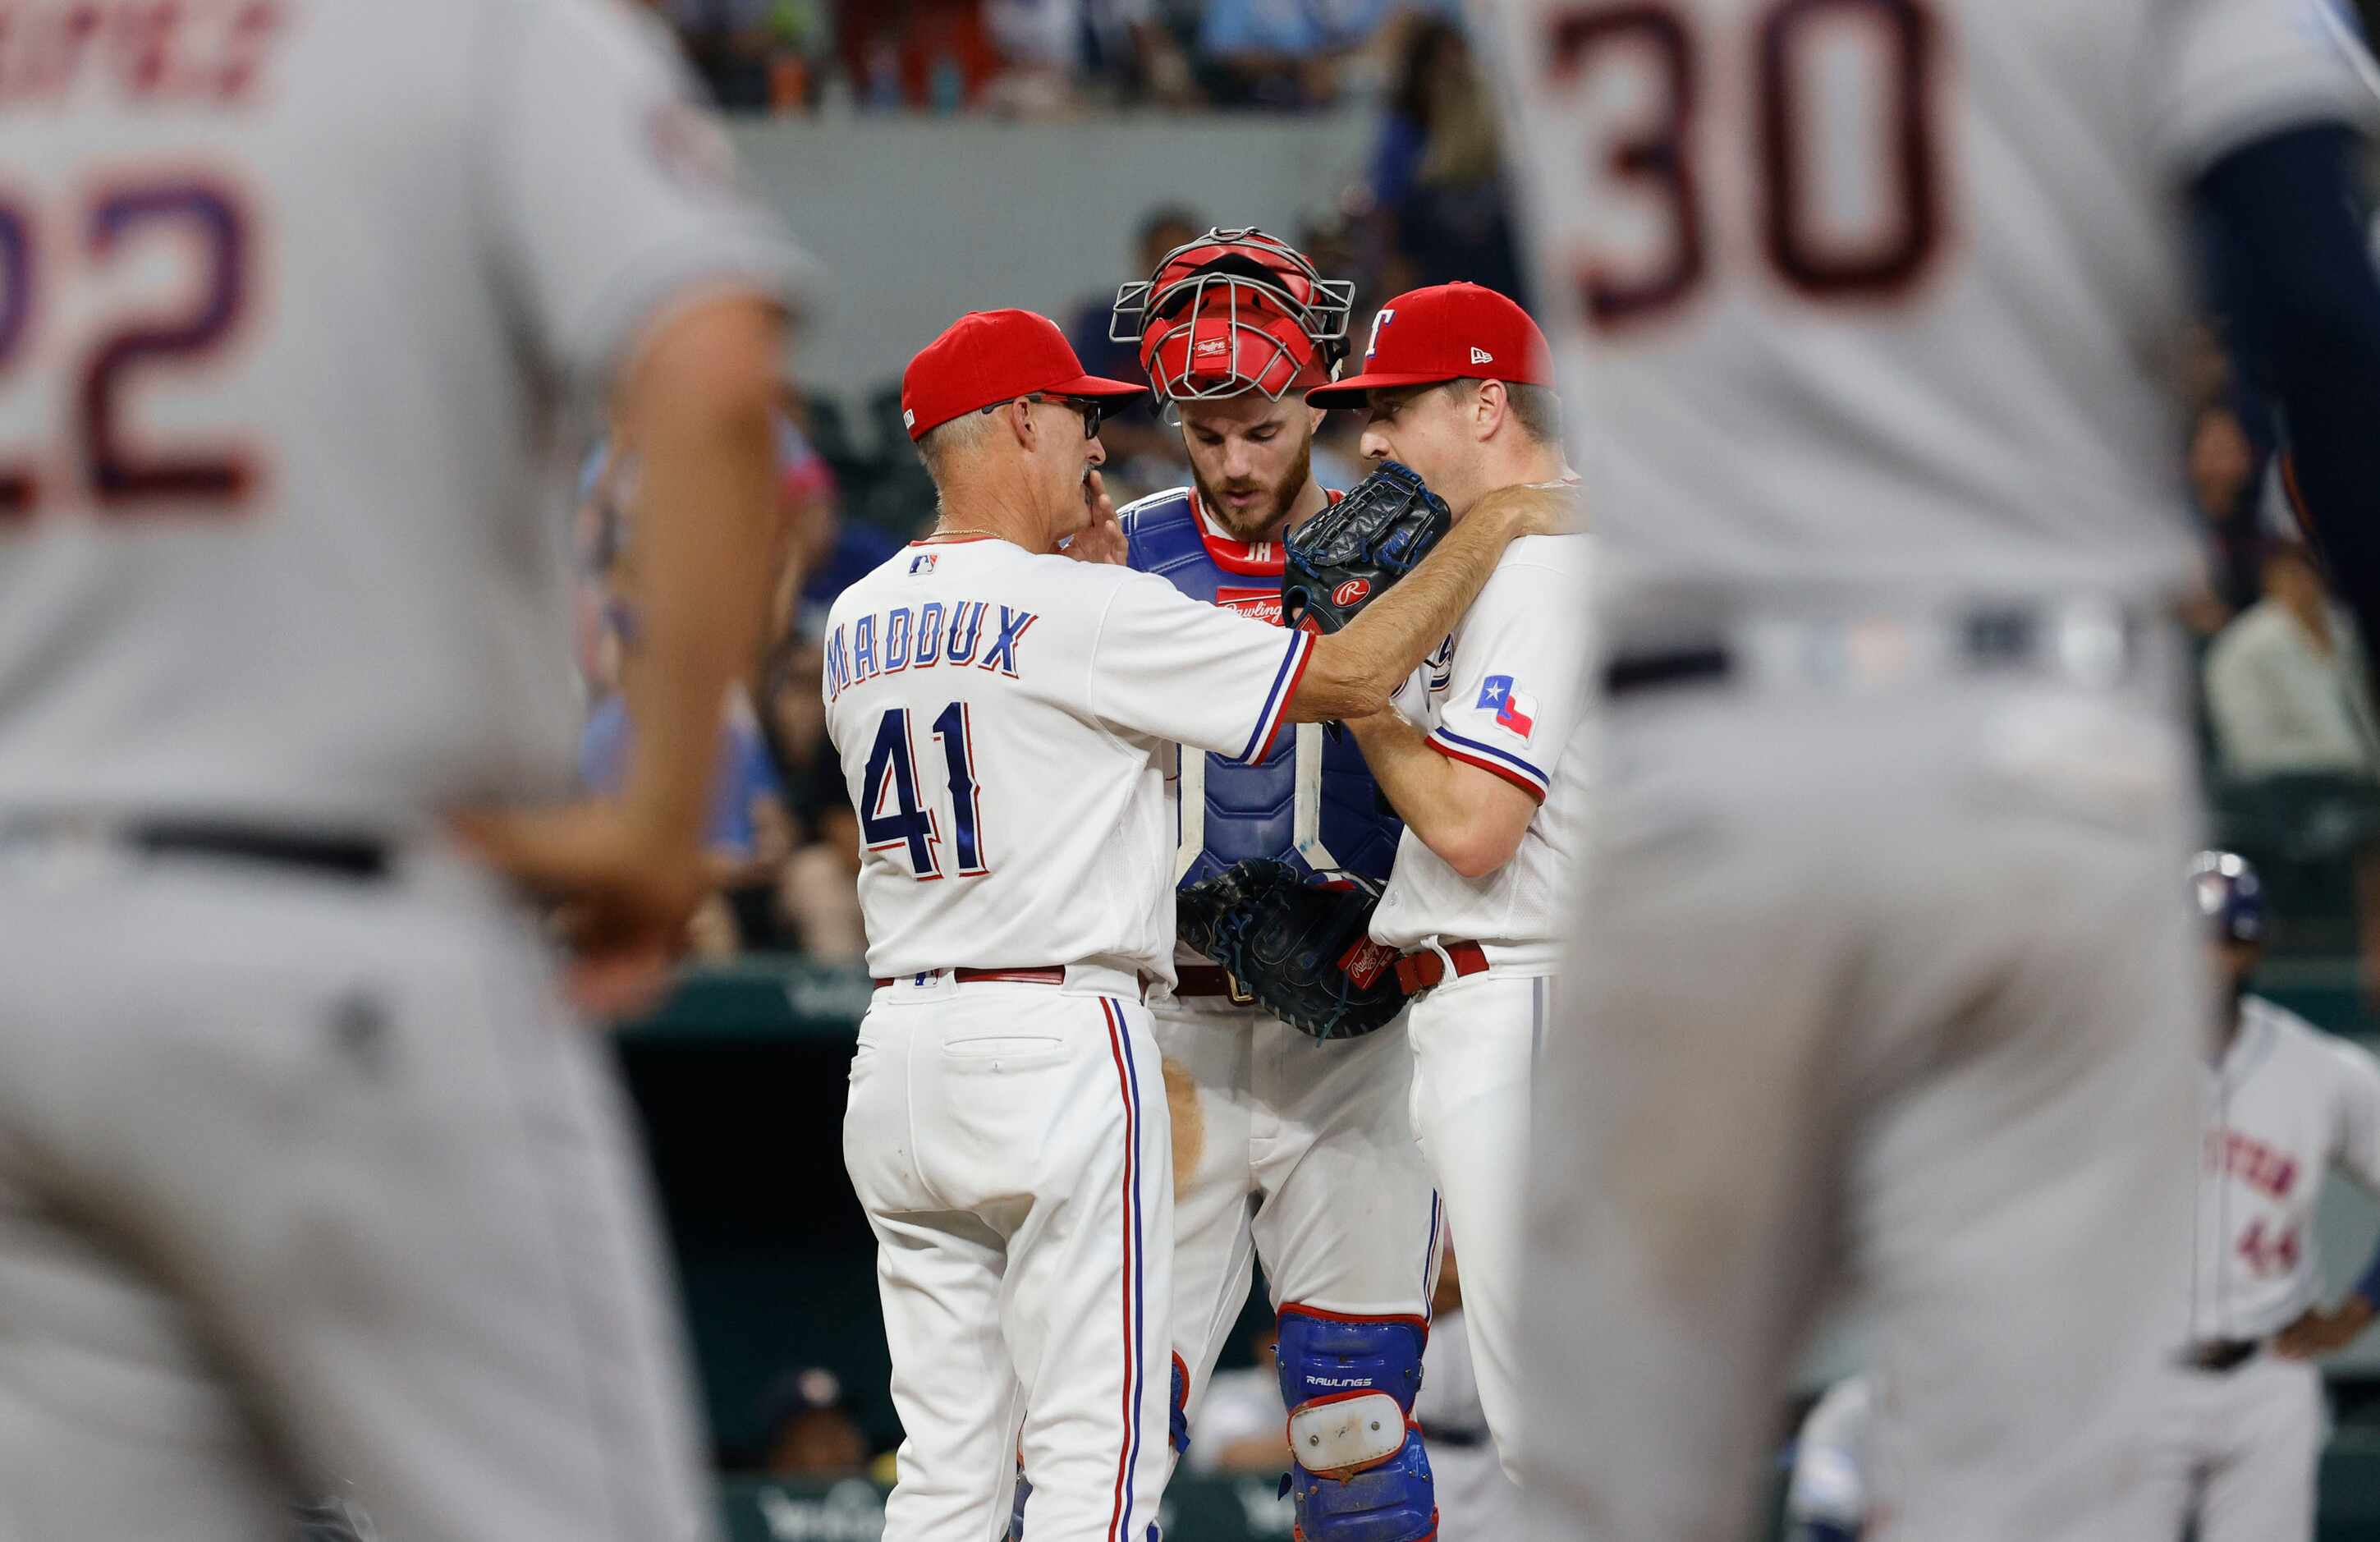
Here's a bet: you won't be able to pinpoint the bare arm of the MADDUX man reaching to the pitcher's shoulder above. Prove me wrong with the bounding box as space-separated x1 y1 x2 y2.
1287 495 1566 723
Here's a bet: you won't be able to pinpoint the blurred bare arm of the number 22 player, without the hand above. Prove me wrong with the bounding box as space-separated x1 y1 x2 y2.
624 295 783 842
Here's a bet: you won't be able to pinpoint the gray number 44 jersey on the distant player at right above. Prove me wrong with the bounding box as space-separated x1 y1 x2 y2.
2190 994 2380 1340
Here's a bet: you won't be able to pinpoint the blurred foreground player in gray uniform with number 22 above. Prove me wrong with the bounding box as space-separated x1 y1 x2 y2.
0 0 792 1542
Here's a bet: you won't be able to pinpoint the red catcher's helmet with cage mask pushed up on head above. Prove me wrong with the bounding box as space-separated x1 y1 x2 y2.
1107 228 1355 402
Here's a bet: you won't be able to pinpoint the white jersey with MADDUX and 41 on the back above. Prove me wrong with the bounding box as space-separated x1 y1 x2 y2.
826 538 1314 983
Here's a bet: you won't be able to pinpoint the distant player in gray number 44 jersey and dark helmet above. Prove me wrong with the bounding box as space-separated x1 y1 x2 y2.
2156 852 2380 1542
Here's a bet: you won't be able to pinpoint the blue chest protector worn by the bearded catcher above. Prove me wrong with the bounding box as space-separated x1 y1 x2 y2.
1119 488 1404 883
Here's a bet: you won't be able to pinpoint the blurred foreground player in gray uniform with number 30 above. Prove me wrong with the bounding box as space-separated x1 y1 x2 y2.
1494 0 2380 1542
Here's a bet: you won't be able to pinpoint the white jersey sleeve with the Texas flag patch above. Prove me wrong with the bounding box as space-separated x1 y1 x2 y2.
1430 535 1588 802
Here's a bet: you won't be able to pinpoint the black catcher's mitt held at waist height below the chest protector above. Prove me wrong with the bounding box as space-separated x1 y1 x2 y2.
1176 859 1404 1039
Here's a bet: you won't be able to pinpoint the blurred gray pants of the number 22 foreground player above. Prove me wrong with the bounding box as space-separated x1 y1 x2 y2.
0 840 714 1542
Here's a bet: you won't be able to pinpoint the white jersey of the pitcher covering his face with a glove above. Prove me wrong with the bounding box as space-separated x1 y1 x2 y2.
1371 535 1588 969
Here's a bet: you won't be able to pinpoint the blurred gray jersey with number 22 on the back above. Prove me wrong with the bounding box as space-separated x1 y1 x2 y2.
0 0 795 826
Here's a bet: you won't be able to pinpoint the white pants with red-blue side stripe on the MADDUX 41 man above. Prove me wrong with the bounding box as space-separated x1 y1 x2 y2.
842 966 1173 1542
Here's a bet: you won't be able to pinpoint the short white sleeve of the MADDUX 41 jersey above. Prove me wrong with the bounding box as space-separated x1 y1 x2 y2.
1085 573 1314 764
